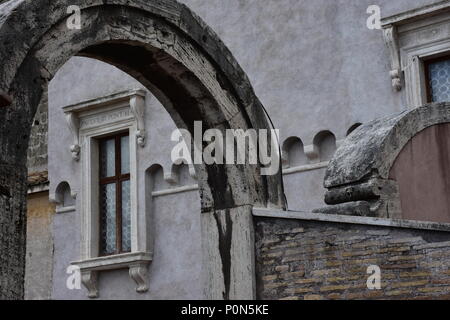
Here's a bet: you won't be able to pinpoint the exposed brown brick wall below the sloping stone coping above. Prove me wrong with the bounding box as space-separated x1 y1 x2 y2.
255 218 450 299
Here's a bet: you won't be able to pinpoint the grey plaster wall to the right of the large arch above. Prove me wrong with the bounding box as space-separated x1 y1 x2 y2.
175 0 440 210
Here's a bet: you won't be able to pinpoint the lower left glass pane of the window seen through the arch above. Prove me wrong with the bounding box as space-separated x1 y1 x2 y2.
100 183 116 254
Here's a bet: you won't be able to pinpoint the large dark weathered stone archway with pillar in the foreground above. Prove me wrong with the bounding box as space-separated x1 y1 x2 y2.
0 0 285 299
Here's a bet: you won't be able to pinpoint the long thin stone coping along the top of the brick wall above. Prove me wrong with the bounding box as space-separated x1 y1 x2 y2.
253 208 450 232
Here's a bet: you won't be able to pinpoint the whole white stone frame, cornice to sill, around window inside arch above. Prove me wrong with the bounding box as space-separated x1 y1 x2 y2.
63 90 152 298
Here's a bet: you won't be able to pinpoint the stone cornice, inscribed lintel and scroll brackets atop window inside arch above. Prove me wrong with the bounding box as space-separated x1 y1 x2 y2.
63 89 146 161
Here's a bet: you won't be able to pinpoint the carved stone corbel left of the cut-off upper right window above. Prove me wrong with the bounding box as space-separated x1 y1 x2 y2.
383 25 402 91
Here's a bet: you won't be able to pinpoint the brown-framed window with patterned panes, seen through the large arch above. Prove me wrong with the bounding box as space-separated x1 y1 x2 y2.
99 132 131 255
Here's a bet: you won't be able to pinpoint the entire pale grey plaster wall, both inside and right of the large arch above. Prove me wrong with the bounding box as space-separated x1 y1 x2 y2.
39 0 446 299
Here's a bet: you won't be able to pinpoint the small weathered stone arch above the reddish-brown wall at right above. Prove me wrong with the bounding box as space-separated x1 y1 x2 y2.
324 103 450 188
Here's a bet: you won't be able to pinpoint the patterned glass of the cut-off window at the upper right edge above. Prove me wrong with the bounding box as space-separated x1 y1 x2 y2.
428 59 450 102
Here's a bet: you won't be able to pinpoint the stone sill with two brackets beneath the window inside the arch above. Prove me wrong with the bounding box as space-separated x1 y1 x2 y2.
72 252 152 298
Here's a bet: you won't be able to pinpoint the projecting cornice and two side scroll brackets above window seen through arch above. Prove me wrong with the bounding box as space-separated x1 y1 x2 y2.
63 89 146 161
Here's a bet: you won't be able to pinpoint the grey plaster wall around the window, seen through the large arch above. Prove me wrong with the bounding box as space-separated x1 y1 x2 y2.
49 58 203 299
